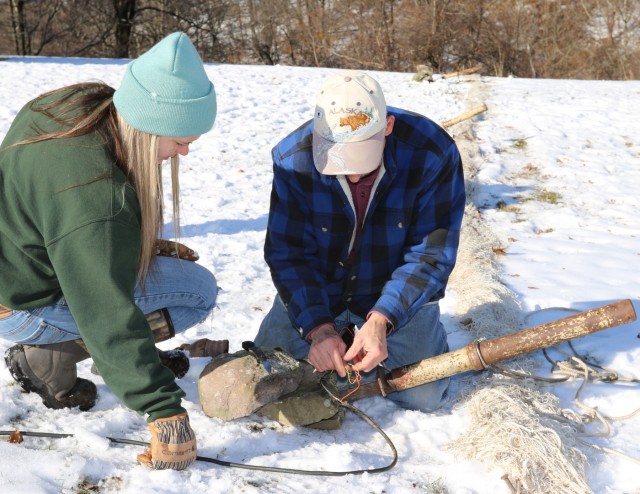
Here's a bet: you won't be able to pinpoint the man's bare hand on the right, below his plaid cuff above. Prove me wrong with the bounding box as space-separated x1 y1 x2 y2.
343 313 388 372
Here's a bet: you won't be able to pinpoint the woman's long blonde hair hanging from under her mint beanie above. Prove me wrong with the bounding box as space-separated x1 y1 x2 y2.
3 83 180 288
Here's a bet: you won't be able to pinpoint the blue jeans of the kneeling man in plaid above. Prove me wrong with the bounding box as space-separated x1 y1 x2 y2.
254 296 449 412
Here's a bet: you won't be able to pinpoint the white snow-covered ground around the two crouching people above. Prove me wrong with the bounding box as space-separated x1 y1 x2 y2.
0 59 640 494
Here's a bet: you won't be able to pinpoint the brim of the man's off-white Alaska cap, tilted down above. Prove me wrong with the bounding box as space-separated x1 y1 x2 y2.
313 129 385 175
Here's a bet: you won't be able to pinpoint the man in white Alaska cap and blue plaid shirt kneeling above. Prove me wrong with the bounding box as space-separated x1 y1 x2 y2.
250 68 465 411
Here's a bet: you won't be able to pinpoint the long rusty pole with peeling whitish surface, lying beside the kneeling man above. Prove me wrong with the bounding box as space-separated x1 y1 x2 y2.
343 299 636 401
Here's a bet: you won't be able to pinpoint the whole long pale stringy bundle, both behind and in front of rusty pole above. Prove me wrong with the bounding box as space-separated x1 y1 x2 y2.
449 103 591 494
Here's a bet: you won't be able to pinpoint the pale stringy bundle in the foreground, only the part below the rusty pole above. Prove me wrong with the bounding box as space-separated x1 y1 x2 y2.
451 383 591 494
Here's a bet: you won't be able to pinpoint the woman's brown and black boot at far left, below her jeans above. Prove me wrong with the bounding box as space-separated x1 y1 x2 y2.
4 341 98 411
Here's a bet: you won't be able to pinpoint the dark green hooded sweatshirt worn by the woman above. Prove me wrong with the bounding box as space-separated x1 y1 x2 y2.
0 91 184 421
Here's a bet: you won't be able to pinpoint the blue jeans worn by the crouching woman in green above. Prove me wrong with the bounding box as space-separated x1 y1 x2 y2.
0 256 218 345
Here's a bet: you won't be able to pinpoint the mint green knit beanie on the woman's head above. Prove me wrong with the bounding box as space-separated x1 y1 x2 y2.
113 32 216 137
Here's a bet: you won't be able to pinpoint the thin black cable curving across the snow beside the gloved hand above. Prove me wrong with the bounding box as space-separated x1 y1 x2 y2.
0 376 398 477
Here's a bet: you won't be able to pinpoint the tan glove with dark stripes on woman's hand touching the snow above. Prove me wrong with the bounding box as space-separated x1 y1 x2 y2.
138 412 197 470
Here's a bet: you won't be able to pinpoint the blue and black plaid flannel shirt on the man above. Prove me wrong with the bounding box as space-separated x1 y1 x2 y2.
264 107 465 337
